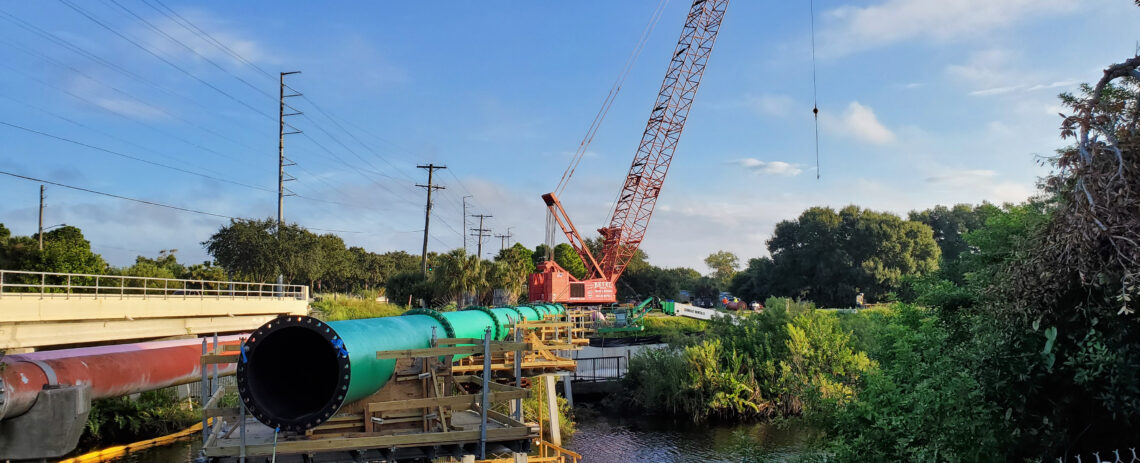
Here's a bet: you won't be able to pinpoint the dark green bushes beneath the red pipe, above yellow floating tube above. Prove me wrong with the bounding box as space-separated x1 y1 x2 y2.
80 388 202 447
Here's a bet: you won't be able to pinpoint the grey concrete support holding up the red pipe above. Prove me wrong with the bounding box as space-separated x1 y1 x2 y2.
0 384 91 461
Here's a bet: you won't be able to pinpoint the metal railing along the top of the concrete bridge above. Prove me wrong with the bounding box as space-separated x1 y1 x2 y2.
0 270 309 300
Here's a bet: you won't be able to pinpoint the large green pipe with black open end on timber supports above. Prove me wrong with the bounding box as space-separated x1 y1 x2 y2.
237 304 565 431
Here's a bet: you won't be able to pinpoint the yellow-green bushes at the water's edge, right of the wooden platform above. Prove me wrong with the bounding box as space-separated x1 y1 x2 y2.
624 299 871 421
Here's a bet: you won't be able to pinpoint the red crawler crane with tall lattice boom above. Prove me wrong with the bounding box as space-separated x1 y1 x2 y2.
528 0 728 304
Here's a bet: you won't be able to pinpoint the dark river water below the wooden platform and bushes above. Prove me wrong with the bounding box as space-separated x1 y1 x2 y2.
117 413 807 463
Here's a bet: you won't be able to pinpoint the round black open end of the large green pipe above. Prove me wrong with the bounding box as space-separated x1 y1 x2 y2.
237 315 351 432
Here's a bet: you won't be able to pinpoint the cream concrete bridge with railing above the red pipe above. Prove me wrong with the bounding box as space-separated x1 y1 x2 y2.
0 270 309 351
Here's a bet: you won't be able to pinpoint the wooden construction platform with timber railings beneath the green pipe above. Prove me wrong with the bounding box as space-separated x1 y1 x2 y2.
202 316 586 463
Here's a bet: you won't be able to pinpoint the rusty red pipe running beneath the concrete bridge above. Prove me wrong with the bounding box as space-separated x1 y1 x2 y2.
0 334 247 420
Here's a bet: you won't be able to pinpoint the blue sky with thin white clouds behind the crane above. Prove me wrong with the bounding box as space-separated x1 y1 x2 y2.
0 0 1140 271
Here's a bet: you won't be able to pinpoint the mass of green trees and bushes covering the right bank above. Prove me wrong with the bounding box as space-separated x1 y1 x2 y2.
627 66 1140 462
